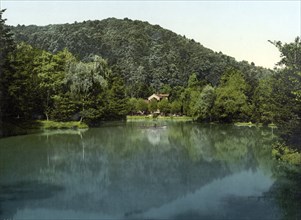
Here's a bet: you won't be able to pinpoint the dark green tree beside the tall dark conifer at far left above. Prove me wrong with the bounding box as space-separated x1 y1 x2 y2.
4 43 43 120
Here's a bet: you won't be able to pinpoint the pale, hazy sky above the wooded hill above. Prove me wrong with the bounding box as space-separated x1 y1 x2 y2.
0 0 301 68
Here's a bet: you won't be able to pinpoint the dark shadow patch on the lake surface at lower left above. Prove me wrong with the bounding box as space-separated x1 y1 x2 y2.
0 181 64 219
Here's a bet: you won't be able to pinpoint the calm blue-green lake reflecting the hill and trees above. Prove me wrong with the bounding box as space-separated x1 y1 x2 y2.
0 121 296 220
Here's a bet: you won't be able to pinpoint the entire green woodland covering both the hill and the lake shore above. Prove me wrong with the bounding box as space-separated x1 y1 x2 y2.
0 11 301 150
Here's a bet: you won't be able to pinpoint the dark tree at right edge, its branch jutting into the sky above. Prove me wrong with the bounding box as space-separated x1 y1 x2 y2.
270 37 301 142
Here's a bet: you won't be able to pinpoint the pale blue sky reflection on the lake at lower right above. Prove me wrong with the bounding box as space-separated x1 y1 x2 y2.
143 170 277 219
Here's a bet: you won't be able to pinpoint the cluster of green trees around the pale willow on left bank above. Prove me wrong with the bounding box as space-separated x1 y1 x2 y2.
4 43 127 123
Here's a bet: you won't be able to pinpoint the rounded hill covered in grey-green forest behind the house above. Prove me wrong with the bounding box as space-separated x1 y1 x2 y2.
11 18 269 97
